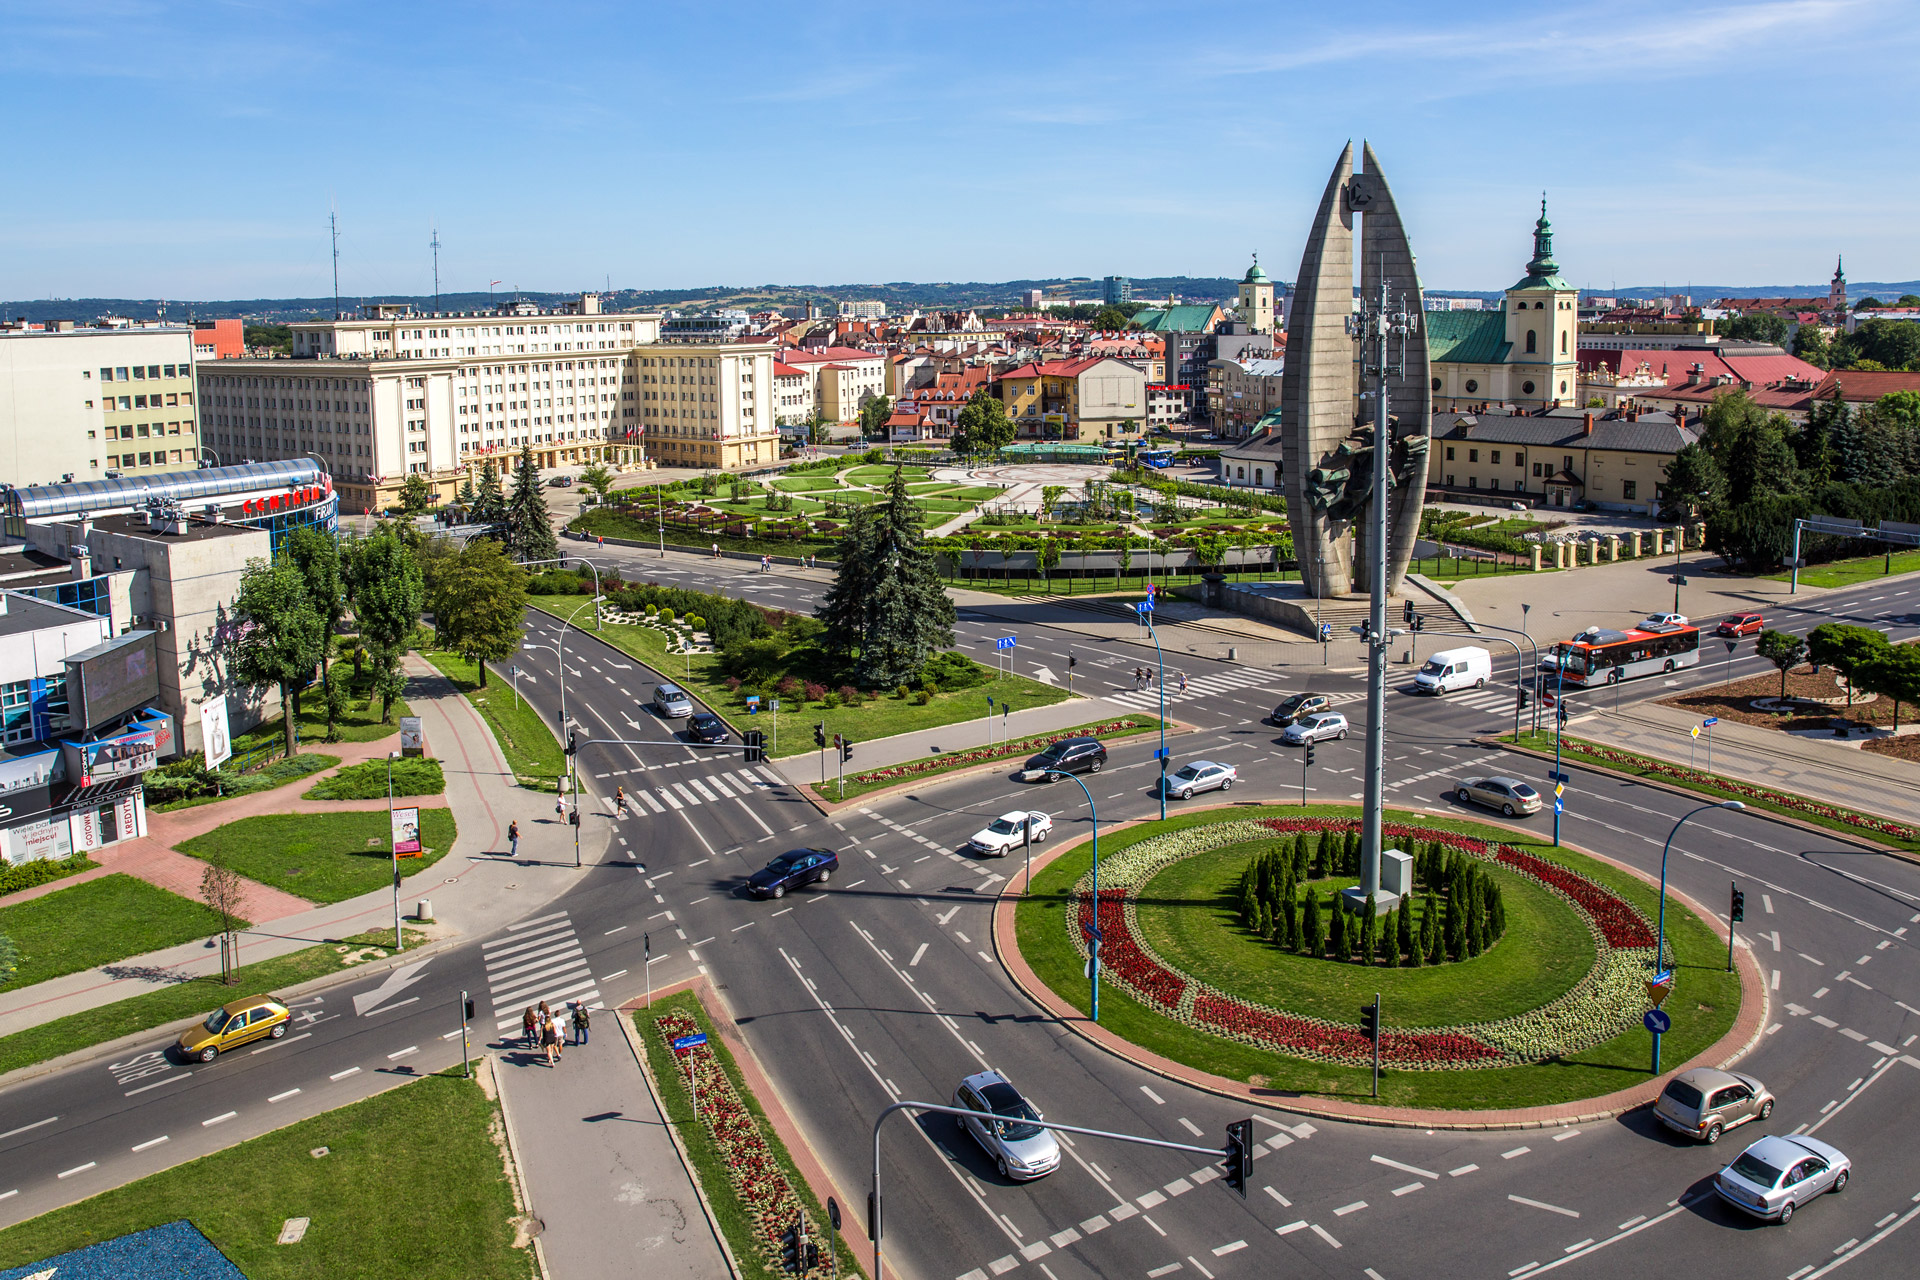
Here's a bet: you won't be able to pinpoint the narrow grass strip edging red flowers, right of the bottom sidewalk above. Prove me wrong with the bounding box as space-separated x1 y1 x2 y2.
634 990 864 1280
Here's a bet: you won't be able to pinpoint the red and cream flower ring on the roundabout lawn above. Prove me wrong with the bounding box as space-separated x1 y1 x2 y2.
1069 818 1653 1071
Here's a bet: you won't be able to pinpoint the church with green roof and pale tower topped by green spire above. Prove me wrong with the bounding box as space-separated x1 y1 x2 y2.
1427 200 1580 413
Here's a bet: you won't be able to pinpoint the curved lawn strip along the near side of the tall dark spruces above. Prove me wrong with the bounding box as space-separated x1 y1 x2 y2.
530 597 1068 766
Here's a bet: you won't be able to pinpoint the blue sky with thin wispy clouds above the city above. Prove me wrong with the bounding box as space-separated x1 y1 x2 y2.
0 0 1920 297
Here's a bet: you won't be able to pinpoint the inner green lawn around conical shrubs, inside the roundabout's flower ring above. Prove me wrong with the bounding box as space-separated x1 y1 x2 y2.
1139 837 1594 1027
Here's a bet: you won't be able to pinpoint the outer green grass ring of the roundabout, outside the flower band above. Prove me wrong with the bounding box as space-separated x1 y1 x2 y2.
1016 806 1740 1111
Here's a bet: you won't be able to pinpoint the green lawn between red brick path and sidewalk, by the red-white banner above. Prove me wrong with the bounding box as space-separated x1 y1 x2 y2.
179 806 455 902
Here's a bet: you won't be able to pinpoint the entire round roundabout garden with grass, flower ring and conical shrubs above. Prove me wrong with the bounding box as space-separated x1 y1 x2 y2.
1016 806 1740 1109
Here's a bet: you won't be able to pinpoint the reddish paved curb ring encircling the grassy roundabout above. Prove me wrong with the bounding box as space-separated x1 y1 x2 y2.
993 802 1772 1132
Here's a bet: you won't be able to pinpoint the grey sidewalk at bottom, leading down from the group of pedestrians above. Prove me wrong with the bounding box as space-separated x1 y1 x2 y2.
493 1009 730 1280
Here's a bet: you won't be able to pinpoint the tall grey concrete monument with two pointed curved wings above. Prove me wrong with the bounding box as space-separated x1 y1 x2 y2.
1281 142 1432 597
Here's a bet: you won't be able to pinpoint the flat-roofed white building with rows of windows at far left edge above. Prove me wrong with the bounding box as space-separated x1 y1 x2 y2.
0 322 200 486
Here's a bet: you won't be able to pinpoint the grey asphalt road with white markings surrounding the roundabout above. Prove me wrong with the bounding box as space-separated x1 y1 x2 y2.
0 560 1920 1280
